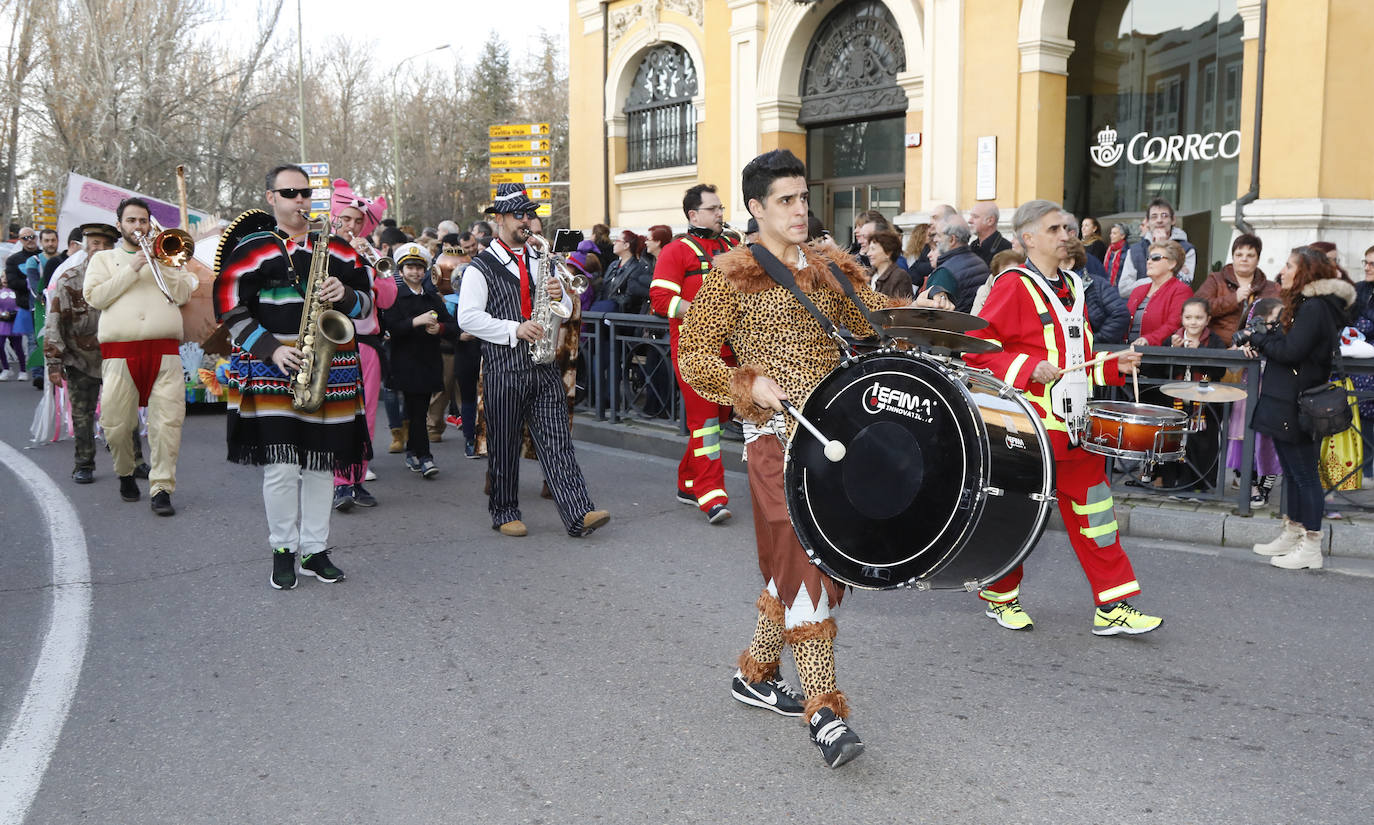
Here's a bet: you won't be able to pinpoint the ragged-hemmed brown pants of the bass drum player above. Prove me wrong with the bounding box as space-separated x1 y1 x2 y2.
745 436 845 608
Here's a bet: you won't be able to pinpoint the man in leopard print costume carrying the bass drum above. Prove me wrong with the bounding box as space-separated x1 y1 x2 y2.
677 150 888 767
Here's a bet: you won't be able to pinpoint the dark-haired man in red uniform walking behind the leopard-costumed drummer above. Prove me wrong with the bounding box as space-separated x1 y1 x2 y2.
649 183 735 524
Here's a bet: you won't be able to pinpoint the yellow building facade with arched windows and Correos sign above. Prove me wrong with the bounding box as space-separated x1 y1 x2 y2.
569 0 1374 277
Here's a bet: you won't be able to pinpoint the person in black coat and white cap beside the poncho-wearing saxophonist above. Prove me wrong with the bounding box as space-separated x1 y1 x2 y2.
382 243 458 479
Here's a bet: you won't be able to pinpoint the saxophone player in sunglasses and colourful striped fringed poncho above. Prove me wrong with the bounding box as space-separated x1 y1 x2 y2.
213 165 372 590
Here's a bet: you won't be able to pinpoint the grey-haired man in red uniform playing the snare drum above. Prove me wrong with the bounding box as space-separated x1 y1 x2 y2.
965 201 1162 635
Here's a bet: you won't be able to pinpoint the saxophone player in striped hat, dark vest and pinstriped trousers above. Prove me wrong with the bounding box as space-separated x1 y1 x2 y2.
458 183 610 536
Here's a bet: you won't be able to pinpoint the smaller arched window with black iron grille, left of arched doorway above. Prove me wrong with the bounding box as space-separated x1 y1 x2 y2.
625 43 697 172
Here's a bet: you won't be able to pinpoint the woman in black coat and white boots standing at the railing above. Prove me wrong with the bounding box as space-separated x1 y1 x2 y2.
1248 246 1355 571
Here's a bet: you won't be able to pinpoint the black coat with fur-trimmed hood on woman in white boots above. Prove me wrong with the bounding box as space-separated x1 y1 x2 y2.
1250 278 1355 443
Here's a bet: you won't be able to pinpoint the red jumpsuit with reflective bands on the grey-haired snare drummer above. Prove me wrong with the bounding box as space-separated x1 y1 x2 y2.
965 270 1140 605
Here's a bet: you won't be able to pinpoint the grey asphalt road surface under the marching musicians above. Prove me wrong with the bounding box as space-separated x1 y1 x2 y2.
0 382 1374 825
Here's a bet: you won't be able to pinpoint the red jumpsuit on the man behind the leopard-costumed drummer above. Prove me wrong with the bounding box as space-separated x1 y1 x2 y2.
649 235 735 513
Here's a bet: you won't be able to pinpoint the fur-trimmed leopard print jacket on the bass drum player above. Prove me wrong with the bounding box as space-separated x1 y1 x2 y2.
677 246 896 436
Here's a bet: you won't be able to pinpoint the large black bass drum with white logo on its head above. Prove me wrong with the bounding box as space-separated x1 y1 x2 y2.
783 349 1054 591
